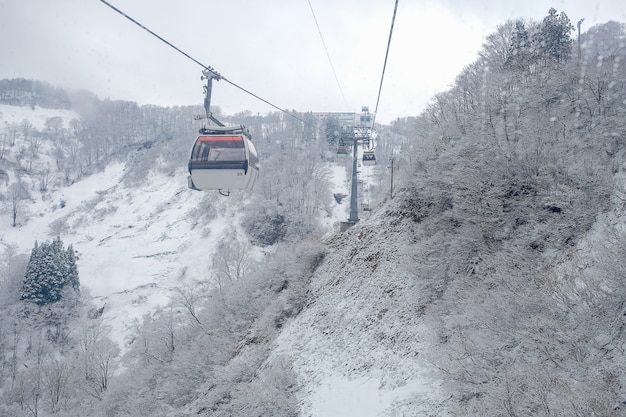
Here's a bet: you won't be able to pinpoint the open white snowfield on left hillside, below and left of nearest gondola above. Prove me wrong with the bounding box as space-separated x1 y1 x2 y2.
0 159 247 347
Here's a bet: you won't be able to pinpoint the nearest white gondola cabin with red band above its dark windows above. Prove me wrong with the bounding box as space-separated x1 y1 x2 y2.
187 126 259 192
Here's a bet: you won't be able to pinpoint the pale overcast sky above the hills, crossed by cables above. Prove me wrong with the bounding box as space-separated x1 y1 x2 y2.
0 0 626 123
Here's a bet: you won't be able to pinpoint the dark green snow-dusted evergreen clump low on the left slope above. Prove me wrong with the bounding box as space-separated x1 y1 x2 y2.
20 237 80 305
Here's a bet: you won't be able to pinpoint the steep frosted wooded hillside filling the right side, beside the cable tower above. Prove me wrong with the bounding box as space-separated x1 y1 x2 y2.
278 11 626 416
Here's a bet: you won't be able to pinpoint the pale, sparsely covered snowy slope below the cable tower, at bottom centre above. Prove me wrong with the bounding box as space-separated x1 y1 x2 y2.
274 199 446 417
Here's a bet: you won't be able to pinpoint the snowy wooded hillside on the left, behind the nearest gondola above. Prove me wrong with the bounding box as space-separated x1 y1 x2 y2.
0 79 391 416
